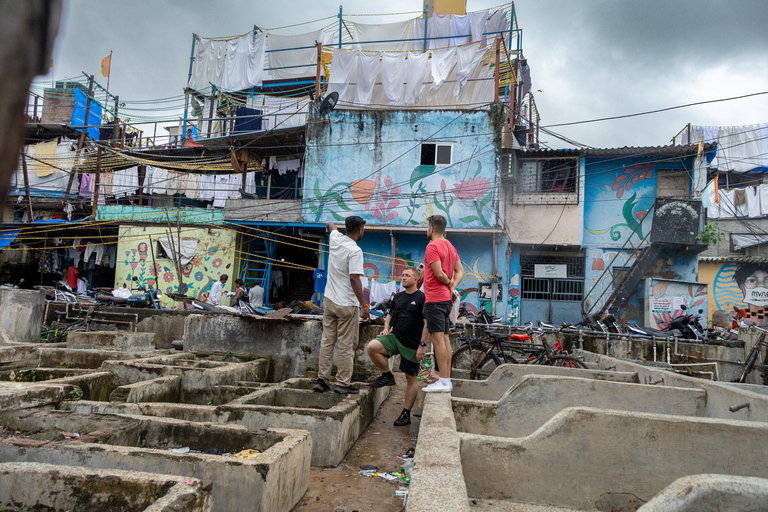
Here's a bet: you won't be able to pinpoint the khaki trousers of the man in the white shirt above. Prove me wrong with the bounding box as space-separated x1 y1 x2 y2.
318 297 360 386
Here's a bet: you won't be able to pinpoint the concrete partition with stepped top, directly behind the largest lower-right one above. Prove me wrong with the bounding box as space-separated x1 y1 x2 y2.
452 375 707 437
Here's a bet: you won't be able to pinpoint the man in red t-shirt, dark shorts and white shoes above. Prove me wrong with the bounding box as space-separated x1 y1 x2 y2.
423 215 464 393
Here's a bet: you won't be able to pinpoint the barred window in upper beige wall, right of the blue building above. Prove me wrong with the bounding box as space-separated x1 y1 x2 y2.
514 158 579 204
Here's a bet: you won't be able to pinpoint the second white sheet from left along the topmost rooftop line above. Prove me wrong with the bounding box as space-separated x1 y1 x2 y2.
224 32 266 89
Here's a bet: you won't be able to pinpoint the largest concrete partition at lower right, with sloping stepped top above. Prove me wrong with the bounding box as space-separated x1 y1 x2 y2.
461 408 768 510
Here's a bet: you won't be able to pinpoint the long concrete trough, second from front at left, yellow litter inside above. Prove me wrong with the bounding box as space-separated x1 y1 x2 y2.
0 411 312 512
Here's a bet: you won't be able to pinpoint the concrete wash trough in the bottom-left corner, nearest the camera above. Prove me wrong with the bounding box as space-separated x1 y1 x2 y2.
0 462 211 512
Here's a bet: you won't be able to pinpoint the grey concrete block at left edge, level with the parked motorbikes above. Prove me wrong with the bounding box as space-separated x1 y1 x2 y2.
0 288 45 344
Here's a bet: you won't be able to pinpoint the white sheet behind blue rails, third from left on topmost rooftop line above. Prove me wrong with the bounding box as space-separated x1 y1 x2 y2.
267 30 331 80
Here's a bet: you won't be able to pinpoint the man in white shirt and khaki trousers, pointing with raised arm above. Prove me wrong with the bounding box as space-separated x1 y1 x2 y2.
313 215 368 395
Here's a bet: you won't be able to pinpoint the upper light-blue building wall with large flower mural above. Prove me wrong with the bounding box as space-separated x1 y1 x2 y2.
302 110 501 228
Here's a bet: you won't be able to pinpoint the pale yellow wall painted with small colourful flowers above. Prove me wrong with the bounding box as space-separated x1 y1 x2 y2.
115 226 237 308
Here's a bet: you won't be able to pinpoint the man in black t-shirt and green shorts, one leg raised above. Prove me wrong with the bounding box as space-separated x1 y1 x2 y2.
367 268 429 427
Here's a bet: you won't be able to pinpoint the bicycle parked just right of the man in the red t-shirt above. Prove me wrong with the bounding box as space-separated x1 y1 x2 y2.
451 322 587 380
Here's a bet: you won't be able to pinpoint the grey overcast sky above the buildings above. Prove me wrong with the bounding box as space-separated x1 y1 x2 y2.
36 0 768 147
